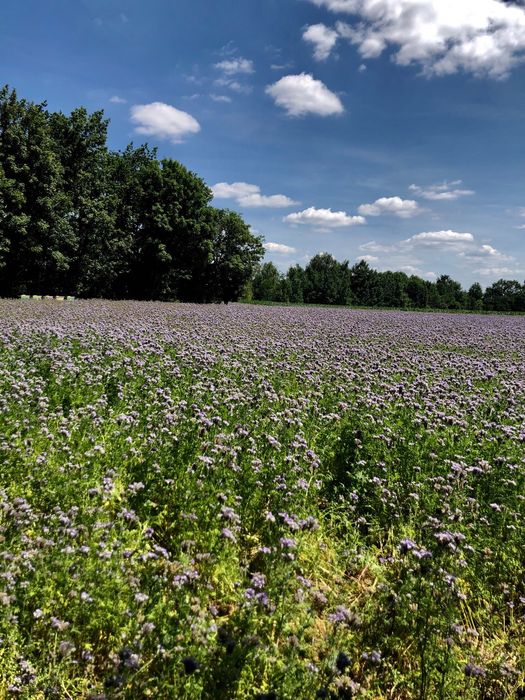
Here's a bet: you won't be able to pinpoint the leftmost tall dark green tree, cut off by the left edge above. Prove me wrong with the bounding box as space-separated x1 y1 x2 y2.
0 86 74 295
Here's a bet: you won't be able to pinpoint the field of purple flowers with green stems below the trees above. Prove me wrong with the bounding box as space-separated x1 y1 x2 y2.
0 301 525 700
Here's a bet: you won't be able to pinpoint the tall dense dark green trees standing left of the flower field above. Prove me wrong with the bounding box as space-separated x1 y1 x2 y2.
0 86 264 301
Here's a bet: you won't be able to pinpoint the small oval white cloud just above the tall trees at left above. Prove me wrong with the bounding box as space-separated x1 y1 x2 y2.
131 102 201 143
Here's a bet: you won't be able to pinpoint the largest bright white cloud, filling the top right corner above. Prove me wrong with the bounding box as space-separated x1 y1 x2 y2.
304 0 525 78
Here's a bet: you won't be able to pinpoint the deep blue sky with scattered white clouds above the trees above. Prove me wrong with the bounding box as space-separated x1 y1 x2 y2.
0 0 525 286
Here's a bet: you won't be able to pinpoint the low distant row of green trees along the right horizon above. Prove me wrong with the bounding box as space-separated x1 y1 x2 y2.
247 253 525 311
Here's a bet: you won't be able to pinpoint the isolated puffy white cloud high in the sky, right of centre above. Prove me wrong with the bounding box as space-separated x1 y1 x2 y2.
266 73 344 117
